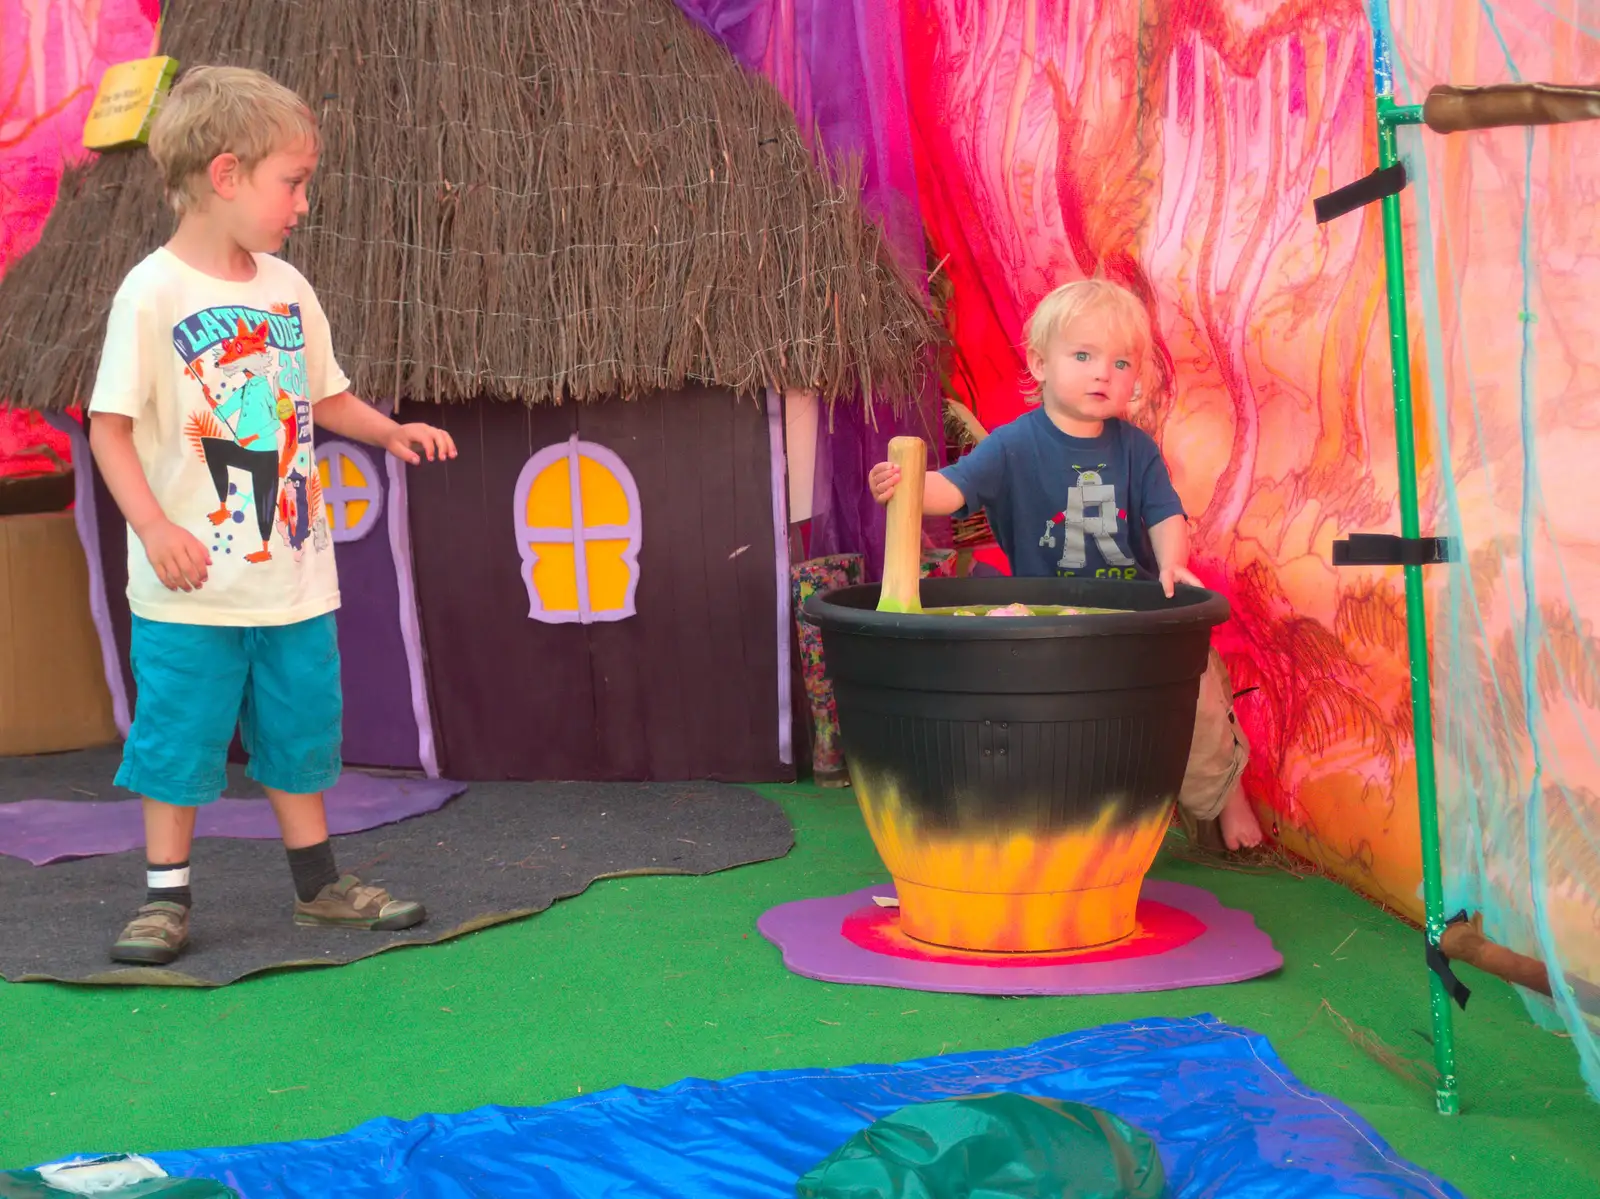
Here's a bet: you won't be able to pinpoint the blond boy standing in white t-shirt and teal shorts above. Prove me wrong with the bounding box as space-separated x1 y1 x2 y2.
90 67 456 965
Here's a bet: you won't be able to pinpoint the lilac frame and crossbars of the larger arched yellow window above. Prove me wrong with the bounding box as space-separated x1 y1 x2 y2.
512 434 643 624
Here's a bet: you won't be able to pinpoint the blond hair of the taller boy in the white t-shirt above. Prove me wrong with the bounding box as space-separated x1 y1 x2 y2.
150 67 322 216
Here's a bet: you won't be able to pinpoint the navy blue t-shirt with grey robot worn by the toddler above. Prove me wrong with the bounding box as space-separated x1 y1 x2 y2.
941 408 1184 578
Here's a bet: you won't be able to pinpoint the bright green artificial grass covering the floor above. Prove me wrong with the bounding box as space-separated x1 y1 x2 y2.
0 786 1600 1199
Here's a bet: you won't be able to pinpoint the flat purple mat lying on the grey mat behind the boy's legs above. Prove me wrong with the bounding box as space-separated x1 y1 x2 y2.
0 770 467 866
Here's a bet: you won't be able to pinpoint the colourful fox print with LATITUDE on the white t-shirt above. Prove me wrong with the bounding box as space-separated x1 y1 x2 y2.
173 304 328 562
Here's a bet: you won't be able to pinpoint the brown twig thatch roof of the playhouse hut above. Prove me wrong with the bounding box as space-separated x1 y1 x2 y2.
0 0 939 408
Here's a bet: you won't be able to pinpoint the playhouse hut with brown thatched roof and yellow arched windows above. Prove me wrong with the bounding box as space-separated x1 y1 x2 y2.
0 0 939 780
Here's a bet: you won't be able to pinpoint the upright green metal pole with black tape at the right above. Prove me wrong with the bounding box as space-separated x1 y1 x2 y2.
1374 88 1459 1116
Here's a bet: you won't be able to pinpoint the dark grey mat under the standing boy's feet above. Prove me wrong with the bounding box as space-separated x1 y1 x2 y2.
0 783 794 986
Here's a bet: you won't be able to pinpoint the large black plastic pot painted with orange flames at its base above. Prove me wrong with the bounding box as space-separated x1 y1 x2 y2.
805 578 1229 951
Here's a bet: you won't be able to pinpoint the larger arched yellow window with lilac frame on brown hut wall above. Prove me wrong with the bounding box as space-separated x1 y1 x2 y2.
514 434 642 624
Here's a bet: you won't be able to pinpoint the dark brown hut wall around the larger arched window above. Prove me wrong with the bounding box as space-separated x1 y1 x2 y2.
408 391 794 781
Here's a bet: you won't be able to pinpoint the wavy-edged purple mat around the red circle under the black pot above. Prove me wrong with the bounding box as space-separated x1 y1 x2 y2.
755 879 1283 996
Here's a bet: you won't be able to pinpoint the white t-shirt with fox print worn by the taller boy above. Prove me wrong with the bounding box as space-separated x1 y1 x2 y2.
90 248 350 626
